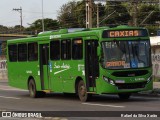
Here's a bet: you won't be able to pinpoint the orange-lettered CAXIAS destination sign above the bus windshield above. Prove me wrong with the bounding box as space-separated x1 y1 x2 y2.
102 30 147 38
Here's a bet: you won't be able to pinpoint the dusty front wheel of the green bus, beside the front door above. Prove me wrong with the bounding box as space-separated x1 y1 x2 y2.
77 80 91 102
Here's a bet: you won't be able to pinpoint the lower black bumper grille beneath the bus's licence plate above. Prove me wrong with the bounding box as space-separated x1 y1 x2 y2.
116 82 147 89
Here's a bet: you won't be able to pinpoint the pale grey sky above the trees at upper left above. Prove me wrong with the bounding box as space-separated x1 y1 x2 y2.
0 0 71 27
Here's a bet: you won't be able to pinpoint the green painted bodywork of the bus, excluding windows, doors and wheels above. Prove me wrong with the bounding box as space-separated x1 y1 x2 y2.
7 27 153 94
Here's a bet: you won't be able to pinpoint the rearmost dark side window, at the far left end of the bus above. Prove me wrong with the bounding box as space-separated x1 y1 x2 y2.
8 45 17 62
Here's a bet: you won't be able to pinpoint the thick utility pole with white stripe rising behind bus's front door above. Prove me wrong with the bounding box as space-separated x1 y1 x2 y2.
86 0 92 28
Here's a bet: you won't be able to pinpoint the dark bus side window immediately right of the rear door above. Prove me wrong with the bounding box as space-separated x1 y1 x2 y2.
50 40 60 60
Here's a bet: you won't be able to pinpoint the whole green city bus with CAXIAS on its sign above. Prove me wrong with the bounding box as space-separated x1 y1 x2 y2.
7 25 153 101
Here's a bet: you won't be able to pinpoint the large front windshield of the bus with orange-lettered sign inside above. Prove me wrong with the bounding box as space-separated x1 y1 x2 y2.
102 40 150 69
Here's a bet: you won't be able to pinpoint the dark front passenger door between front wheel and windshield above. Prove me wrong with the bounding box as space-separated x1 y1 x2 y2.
85 40 99 92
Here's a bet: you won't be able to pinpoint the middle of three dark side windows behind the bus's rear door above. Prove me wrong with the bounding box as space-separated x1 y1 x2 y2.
18 44 27 61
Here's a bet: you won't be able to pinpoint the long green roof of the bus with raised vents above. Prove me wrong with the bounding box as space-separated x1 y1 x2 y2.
7 25 148 43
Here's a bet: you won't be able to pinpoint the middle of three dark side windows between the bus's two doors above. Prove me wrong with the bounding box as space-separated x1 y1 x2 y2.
61 40 71 60
